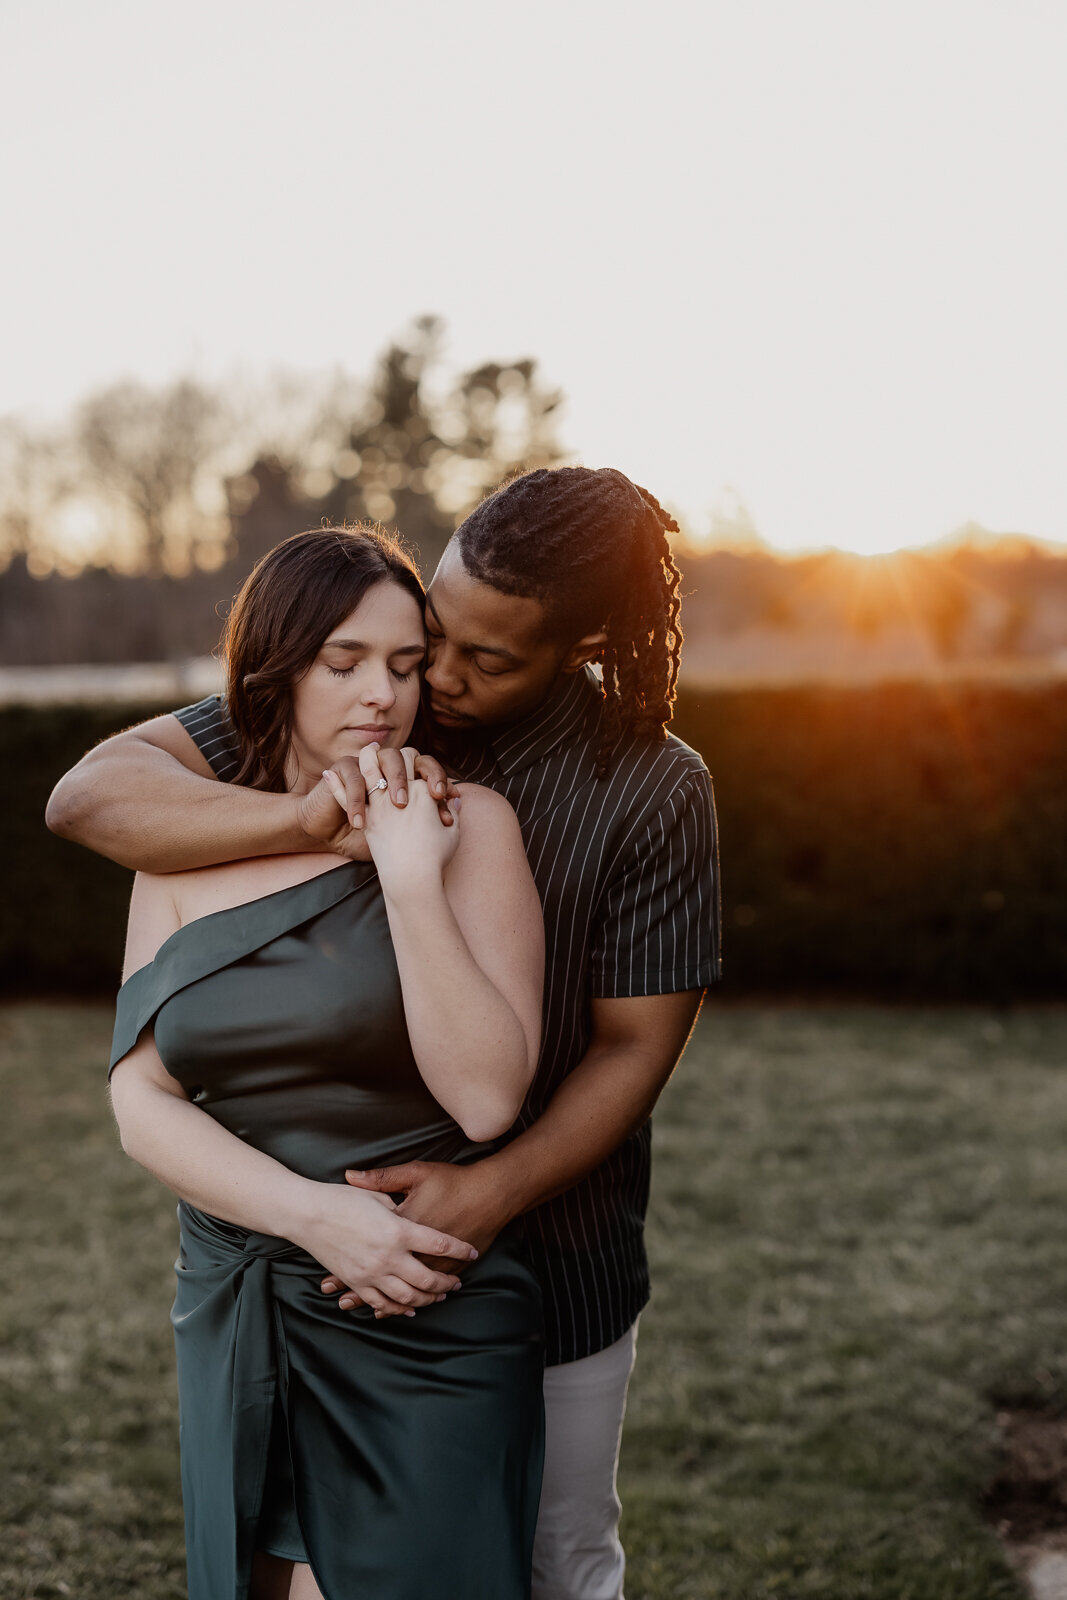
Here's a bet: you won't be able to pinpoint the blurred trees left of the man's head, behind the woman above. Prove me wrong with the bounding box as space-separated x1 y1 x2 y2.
0 317 563 664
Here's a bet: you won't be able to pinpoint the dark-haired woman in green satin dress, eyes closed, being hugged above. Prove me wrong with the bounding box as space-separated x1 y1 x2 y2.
110 528 544 1600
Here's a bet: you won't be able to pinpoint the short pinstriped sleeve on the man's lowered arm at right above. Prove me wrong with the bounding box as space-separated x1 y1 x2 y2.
590 770 721 1000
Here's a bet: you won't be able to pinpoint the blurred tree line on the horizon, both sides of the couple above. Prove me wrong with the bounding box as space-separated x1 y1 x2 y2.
0 317 1067 678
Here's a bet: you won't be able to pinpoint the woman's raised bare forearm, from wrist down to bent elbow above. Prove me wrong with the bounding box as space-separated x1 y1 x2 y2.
382 880 536 1141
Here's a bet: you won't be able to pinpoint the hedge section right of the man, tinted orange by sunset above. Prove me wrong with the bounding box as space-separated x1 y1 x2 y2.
687 682 1067 1000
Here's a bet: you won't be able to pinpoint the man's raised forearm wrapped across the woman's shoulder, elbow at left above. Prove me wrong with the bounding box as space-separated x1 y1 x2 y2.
46 739 308 872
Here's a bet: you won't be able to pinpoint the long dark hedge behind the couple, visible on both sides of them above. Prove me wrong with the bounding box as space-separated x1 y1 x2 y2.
0 682 1067 1000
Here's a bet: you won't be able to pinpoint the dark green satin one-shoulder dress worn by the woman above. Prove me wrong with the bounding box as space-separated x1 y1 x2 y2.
112 862 544 1600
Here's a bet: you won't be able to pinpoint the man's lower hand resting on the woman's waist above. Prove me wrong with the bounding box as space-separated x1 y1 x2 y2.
322 1158 514 1310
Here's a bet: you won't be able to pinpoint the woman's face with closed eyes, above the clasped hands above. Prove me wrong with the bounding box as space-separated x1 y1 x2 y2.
290 579 426 794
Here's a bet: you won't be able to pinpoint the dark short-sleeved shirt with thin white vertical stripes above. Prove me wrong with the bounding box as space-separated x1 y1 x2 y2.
178 672 720 1365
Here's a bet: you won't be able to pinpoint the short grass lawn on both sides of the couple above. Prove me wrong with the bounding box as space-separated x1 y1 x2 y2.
0 1003 1067 1600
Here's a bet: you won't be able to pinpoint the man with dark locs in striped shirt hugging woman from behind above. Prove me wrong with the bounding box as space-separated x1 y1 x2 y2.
50 467 718 1600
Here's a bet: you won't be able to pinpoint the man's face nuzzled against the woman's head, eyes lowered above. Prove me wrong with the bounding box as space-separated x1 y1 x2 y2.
424 539 581 733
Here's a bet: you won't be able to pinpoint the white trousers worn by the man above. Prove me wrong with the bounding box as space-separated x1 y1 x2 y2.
533 1323 637 1600
